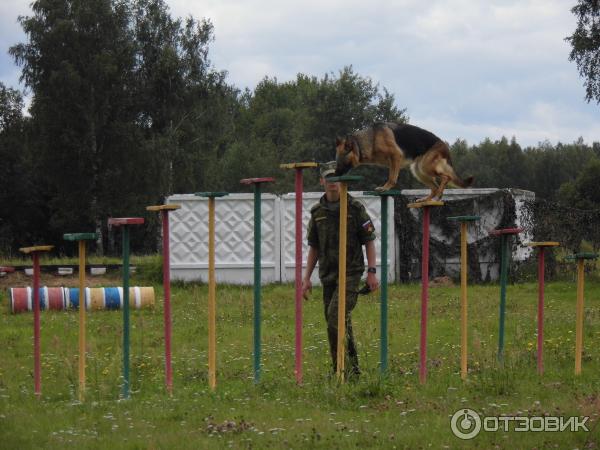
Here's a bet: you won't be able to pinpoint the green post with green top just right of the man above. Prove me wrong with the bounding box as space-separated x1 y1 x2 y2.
364 190 402 375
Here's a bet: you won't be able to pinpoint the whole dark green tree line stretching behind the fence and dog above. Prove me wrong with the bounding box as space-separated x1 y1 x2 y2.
0 0 600 254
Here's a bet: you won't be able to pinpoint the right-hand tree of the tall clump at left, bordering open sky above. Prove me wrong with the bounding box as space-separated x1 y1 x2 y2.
133 0 236 195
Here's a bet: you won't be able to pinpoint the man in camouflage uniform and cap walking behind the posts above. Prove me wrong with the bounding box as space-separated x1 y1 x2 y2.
302 161 379 376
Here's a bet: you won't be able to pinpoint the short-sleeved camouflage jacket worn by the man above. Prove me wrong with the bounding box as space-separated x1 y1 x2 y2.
307 195 375 284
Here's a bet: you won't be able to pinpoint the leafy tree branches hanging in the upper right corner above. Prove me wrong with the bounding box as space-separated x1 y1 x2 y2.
566 0 600 103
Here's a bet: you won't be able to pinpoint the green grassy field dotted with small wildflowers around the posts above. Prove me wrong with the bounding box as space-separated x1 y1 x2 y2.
0 279 600 449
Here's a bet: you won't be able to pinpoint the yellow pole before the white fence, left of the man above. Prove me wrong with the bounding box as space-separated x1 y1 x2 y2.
208 197 217 390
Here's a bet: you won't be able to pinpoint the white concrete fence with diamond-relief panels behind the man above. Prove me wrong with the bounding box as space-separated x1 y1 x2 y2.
167 192 396 284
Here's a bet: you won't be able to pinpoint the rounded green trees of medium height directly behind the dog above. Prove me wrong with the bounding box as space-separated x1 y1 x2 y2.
222 67 407 192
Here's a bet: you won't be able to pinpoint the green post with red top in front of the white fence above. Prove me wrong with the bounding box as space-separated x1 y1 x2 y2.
240 178 275 383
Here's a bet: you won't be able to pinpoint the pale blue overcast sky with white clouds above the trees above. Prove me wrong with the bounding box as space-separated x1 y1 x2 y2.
0 0 600 145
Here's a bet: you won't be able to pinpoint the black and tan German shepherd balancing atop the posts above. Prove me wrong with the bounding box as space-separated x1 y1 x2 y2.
335 122 473 201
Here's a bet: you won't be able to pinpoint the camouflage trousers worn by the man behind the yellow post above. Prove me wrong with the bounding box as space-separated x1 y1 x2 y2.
323 274 361 375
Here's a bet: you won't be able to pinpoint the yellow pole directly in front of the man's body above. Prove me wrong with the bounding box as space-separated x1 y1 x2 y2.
337 182 348 381
